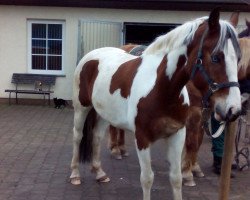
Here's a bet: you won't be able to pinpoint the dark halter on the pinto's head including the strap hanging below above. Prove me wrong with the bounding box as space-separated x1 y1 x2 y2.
190 28 240 136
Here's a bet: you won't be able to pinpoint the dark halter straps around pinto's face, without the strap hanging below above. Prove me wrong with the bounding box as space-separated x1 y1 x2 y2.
191 28 240 109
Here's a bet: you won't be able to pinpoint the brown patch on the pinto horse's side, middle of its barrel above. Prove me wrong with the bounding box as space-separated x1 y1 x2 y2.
109 57 142 98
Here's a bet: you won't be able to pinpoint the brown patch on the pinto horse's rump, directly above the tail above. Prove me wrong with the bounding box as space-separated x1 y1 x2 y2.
79 60 99 107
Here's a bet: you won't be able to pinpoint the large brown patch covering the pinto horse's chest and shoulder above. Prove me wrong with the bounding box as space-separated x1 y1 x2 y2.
135 55 188 150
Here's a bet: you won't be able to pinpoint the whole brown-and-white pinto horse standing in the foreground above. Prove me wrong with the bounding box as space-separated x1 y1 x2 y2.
70 9 241 200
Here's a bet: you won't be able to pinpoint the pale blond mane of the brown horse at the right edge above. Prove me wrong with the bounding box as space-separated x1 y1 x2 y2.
238 38 250 72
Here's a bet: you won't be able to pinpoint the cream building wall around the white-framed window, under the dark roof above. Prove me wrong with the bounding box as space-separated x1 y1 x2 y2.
0 6 250 100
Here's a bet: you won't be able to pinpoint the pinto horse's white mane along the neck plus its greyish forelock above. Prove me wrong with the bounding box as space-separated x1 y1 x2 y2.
143 17 240 58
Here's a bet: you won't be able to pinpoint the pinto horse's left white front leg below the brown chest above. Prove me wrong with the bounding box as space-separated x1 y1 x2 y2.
136 142 154 200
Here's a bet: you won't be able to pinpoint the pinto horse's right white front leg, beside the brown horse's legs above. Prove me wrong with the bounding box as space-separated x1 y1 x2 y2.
166 127 186 200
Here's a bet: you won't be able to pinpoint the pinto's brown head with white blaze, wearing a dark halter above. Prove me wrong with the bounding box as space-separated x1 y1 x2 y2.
187 9 241 121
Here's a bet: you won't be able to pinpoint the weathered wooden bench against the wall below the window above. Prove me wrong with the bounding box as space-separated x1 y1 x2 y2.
5 73 56 105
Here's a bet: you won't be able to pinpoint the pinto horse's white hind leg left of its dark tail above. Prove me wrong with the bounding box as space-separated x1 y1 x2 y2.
70 108 90 185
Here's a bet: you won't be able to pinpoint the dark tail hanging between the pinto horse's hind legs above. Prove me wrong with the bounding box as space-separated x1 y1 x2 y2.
79 108 97 162
